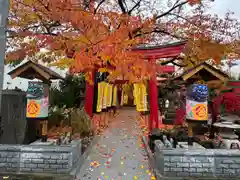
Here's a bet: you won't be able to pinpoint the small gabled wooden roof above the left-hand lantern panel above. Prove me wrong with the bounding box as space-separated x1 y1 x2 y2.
8 61 64 81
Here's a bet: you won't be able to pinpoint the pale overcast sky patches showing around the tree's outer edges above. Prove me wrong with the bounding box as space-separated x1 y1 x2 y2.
3 0 240 90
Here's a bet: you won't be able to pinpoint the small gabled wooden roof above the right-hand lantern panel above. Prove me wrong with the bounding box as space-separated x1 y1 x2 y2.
173 62 229 81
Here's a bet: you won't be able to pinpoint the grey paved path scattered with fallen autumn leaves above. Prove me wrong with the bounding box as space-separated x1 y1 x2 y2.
77 109 155 180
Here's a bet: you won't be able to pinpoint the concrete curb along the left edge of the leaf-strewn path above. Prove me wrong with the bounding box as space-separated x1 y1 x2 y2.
70 135 101 179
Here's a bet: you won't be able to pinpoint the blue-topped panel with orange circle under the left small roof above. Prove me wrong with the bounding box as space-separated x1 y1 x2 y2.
27 82 49 118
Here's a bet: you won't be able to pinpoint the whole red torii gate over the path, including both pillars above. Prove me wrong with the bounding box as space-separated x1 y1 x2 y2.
85 42 186 132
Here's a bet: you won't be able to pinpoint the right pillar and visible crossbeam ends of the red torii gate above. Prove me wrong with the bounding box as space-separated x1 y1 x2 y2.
133 41 186 132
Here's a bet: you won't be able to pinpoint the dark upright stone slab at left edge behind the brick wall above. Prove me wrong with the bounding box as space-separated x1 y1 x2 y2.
0 90 27 144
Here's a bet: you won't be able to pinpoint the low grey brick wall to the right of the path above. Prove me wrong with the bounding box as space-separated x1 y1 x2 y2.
154 141 240 179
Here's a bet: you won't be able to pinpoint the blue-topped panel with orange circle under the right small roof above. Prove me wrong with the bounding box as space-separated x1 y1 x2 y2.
186 84 208 121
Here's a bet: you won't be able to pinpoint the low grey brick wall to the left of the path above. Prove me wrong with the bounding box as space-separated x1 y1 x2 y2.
0 141 81 178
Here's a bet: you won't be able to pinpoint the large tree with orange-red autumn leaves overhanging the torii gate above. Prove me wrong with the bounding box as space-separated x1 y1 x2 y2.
6 0 239 81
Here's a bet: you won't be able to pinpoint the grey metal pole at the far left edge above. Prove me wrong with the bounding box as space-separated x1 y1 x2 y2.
0 0 9 114
